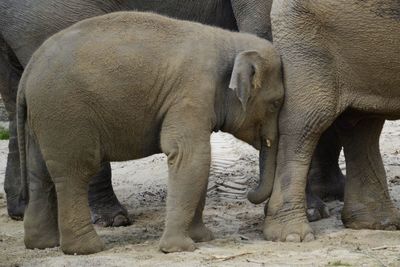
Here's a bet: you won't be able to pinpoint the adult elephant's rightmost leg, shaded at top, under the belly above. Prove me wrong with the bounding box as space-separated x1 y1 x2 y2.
340 118 400 230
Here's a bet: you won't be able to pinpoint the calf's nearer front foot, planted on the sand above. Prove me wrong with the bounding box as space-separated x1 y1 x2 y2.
159 233 196 253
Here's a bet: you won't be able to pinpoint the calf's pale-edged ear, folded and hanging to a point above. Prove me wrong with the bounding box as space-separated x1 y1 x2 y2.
229 51 262 111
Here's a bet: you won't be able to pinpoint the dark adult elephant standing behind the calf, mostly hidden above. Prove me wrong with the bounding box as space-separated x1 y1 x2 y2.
0 0 343 226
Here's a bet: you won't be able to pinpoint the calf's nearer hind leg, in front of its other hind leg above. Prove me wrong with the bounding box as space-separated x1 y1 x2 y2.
44 157 105 254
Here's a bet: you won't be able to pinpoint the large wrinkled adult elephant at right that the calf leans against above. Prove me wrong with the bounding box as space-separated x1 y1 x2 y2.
264 0 400 242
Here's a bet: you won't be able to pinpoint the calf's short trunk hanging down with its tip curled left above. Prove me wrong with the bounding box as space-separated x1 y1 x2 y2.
247 139 278 204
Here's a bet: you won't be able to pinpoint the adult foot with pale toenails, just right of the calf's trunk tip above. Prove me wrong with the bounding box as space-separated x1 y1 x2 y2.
264 212 315 242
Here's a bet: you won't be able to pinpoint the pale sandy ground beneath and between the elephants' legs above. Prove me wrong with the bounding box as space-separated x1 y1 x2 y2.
0 122 400 266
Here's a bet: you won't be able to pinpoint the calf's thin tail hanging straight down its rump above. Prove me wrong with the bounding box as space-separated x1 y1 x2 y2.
17 84 29 203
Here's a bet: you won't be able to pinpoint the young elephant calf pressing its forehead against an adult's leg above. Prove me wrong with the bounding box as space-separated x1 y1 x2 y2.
18 12 284 254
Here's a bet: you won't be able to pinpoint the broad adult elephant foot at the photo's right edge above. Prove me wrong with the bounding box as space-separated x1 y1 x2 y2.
342 200 400 230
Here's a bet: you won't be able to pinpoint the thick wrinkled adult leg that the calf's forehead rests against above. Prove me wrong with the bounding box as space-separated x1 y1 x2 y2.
264 40 340 242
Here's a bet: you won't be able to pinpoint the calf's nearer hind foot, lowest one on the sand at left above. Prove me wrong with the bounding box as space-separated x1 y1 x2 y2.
61 230 105 255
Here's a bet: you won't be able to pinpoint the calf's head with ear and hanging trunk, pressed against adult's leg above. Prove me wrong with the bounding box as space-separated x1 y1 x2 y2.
229 46 284 203
